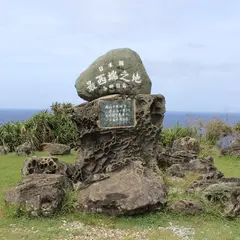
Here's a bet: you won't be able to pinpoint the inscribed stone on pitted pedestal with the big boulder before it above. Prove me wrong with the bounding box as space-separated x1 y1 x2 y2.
71 49 166 215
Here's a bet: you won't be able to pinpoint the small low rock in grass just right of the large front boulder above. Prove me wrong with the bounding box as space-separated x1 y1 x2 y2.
168 199 204 215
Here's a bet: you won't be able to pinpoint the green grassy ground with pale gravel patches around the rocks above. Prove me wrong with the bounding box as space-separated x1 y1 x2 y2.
0 153 240 240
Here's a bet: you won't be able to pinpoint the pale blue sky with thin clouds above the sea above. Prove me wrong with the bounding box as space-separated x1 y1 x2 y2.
0 0 240 113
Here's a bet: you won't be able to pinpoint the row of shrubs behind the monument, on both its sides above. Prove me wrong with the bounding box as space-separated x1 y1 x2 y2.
0 102 240 152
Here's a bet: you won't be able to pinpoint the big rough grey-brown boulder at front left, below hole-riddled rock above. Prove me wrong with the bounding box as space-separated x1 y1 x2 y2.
5 174 73 216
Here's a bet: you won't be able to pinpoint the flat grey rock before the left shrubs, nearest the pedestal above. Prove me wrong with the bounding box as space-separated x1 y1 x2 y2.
42 143 71 155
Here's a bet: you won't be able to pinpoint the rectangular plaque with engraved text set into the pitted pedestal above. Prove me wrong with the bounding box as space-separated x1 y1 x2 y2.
99 99 136 128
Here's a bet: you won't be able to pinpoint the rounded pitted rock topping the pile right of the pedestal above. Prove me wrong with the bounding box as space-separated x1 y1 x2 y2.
172 137 200 154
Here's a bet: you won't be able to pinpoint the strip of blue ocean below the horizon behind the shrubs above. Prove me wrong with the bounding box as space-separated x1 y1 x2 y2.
0 109 240 127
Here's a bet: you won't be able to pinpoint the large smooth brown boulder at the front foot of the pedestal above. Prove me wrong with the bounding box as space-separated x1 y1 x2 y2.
78 162 167 216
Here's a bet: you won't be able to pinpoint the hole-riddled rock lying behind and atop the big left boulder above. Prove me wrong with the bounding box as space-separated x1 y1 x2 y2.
21 156 75 179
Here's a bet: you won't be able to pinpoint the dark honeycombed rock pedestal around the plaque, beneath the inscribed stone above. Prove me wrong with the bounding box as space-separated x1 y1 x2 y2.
71 94 165 182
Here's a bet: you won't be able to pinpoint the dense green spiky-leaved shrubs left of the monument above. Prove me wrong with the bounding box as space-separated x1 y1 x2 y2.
0 102 77 151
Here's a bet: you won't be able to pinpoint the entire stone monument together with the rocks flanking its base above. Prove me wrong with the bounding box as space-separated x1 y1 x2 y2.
5 49 240 217
